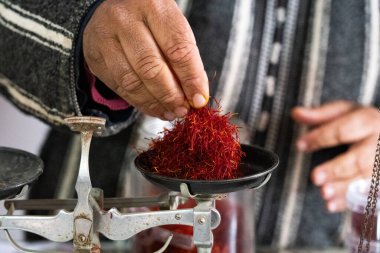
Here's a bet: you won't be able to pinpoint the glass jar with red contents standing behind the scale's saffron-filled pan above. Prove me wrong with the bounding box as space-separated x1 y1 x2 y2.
123 116 255 253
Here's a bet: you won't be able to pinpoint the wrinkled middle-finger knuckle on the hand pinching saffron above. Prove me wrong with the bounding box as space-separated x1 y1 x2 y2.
136 54 164 80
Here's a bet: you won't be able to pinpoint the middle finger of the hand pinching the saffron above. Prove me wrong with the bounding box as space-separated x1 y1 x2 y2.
115 20 189 117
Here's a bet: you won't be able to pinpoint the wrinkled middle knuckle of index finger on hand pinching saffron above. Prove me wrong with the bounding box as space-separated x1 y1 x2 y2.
166 42 196 64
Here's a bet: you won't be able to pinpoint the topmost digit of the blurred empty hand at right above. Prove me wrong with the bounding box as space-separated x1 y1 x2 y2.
292 101 355 125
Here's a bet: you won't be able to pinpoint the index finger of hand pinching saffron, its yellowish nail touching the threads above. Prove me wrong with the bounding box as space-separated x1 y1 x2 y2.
145 0 209 108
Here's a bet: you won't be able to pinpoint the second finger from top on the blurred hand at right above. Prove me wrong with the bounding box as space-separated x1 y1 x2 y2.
297 108 380 151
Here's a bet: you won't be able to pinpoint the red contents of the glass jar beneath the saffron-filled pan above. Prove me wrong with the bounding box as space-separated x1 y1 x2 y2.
133 198 248 253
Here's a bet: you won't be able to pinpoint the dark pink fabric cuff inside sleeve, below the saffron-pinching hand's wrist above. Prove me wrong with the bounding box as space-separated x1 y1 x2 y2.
85 65 129 111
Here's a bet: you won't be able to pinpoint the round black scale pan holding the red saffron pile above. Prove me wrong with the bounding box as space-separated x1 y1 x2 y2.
135 145 279 195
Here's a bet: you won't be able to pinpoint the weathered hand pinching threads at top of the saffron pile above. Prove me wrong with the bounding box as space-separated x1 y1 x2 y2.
83 0 209 120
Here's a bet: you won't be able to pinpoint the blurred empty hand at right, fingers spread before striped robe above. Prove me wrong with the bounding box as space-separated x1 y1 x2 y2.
292 101 380 212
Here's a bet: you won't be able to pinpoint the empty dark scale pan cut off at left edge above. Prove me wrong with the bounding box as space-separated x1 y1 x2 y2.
0 147 43 200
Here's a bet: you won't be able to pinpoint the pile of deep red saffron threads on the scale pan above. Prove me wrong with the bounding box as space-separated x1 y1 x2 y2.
145 103 244 180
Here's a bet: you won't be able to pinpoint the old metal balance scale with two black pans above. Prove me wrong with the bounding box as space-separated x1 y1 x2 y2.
0 117 279 253
